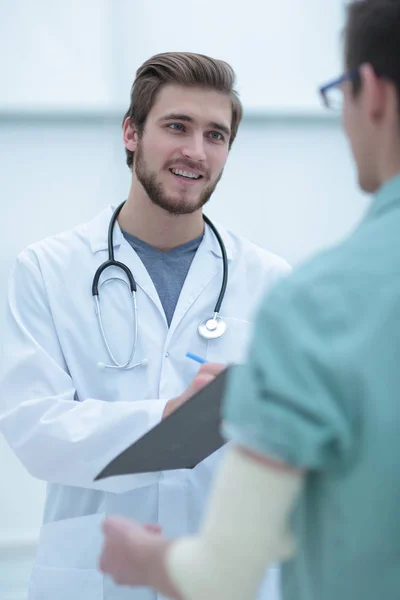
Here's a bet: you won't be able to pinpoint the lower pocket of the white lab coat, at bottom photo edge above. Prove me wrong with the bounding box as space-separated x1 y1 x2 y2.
28 566 104 600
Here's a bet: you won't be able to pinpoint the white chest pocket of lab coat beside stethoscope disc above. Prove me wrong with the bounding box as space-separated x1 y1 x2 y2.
207 317 253 364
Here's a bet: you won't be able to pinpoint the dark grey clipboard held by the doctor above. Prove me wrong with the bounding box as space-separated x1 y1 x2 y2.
95 366 232 481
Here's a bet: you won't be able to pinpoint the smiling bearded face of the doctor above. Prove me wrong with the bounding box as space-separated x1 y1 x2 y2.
128 84 232 214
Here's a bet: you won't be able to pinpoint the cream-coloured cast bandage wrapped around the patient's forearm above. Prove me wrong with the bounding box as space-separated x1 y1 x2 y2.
167 448 302 600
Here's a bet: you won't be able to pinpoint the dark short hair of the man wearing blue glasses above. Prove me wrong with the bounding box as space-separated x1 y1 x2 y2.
344 0 400 110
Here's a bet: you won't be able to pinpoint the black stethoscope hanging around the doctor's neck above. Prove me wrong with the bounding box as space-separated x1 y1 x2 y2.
92 201 228 369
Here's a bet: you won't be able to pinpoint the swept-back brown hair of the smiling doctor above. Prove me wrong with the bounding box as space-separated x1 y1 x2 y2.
123 52 243 169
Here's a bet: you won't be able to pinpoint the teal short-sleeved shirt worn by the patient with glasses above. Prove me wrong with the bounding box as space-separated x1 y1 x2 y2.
223 176 400 600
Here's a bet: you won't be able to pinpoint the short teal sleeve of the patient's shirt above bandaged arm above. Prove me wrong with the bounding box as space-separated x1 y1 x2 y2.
223 276 357 470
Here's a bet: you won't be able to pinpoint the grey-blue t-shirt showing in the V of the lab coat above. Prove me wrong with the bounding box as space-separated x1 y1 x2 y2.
122 231 203 326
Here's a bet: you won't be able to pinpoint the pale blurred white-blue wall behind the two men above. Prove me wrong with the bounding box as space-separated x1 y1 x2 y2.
0 0 368 600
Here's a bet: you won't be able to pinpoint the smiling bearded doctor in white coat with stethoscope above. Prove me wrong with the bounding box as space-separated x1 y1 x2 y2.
0 53 289 600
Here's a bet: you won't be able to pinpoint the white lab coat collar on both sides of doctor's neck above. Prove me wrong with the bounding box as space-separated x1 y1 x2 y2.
87 206 233 260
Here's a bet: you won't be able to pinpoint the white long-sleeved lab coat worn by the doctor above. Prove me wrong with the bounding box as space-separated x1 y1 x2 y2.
0 207 289 600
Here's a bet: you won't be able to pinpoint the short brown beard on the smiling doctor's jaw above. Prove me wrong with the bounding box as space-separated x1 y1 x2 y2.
135 142 223 215
